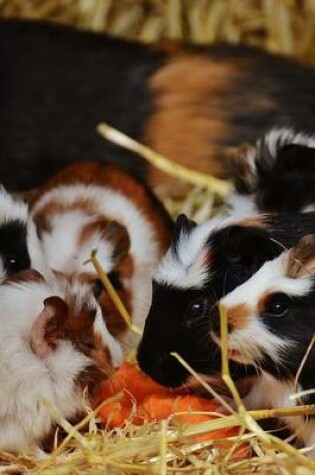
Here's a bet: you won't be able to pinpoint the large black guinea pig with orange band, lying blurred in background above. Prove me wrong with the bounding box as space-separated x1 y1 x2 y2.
0 19 315 190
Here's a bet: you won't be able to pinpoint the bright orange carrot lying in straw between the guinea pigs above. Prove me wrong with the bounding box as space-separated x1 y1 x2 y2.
99 363 250 459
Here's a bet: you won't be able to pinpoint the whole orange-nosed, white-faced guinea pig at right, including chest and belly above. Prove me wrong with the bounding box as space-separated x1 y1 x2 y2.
211 234 315 457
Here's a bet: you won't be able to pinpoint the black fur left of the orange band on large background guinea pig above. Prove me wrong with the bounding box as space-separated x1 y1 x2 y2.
0 19 168 190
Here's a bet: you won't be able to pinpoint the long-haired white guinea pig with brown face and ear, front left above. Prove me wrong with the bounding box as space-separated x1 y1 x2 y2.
0 269 122 457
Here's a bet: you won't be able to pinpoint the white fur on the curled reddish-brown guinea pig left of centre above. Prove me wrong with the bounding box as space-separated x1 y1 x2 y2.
32 184 159 352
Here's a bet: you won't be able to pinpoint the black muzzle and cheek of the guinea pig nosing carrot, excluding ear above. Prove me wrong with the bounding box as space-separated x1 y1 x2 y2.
138 283 254 387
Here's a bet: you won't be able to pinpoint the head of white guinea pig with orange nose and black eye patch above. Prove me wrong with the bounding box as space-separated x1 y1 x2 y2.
211 235 315 379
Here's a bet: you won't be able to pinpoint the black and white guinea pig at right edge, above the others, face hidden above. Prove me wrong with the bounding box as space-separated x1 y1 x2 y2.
230 128 315 212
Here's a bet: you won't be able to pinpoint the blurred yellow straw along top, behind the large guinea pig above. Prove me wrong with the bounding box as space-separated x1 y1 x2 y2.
0 0 315 61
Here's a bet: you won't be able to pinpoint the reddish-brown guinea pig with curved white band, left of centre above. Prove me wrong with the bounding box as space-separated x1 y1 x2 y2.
30 162 172 352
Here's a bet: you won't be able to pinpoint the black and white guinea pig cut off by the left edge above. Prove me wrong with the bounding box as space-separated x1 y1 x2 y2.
0 187 48 282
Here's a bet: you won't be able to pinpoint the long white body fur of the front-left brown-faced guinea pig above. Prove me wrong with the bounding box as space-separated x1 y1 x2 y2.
0 283 90 452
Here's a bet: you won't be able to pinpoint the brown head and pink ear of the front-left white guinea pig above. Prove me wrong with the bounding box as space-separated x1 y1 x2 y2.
30 281 122 403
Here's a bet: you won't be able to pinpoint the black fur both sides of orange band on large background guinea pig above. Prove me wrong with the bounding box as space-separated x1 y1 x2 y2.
0 19 315 189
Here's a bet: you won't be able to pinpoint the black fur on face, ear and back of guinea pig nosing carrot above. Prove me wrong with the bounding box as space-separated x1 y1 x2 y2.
138 213 315 387
